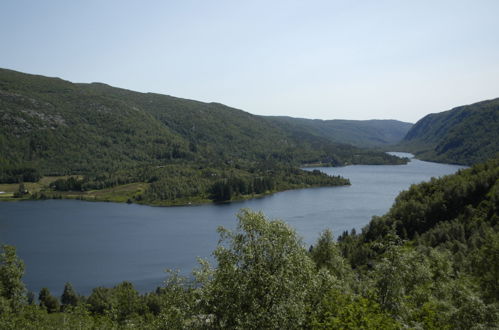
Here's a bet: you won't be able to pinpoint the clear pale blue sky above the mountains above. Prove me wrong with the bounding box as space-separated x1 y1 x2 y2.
0 0 499 122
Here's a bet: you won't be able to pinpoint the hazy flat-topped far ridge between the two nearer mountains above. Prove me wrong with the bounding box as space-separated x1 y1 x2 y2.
266 116 412 148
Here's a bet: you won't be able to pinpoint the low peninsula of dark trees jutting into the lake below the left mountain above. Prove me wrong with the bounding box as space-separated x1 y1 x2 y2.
31 162 350 204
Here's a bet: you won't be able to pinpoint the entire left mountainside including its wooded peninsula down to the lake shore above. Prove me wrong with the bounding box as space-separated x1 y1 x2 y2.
0 69 404 204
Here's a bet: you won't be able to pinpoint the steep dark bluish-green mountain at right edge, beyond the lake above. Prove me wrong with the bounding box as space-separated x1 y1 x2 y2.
400 98 499 165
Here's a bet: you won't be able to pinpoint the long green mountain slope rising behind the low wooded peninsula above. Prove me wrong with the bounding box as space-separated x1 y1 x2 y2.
0 70 404 174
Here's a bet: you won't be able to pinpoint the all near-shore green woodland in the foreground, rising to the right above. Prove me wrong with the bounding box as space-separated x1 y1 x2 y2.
0 159 499 329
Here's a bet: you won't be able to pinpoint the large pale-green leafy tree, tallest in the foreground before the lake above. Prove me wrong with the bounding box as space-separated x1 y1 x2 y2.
198 210 314 329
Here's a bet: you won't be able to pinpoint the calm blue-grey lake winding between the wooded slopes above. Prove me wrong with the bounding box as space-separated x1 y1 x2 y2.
0 153 462 295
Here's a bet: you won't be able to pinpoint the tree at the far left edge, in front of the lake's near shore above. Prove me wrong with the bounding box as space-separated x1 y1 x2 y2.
0 245 26 310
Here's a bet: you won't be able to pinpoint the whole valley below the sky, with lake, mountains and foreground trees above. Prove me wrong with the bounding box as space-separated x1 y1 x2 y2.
0 70 499 329
